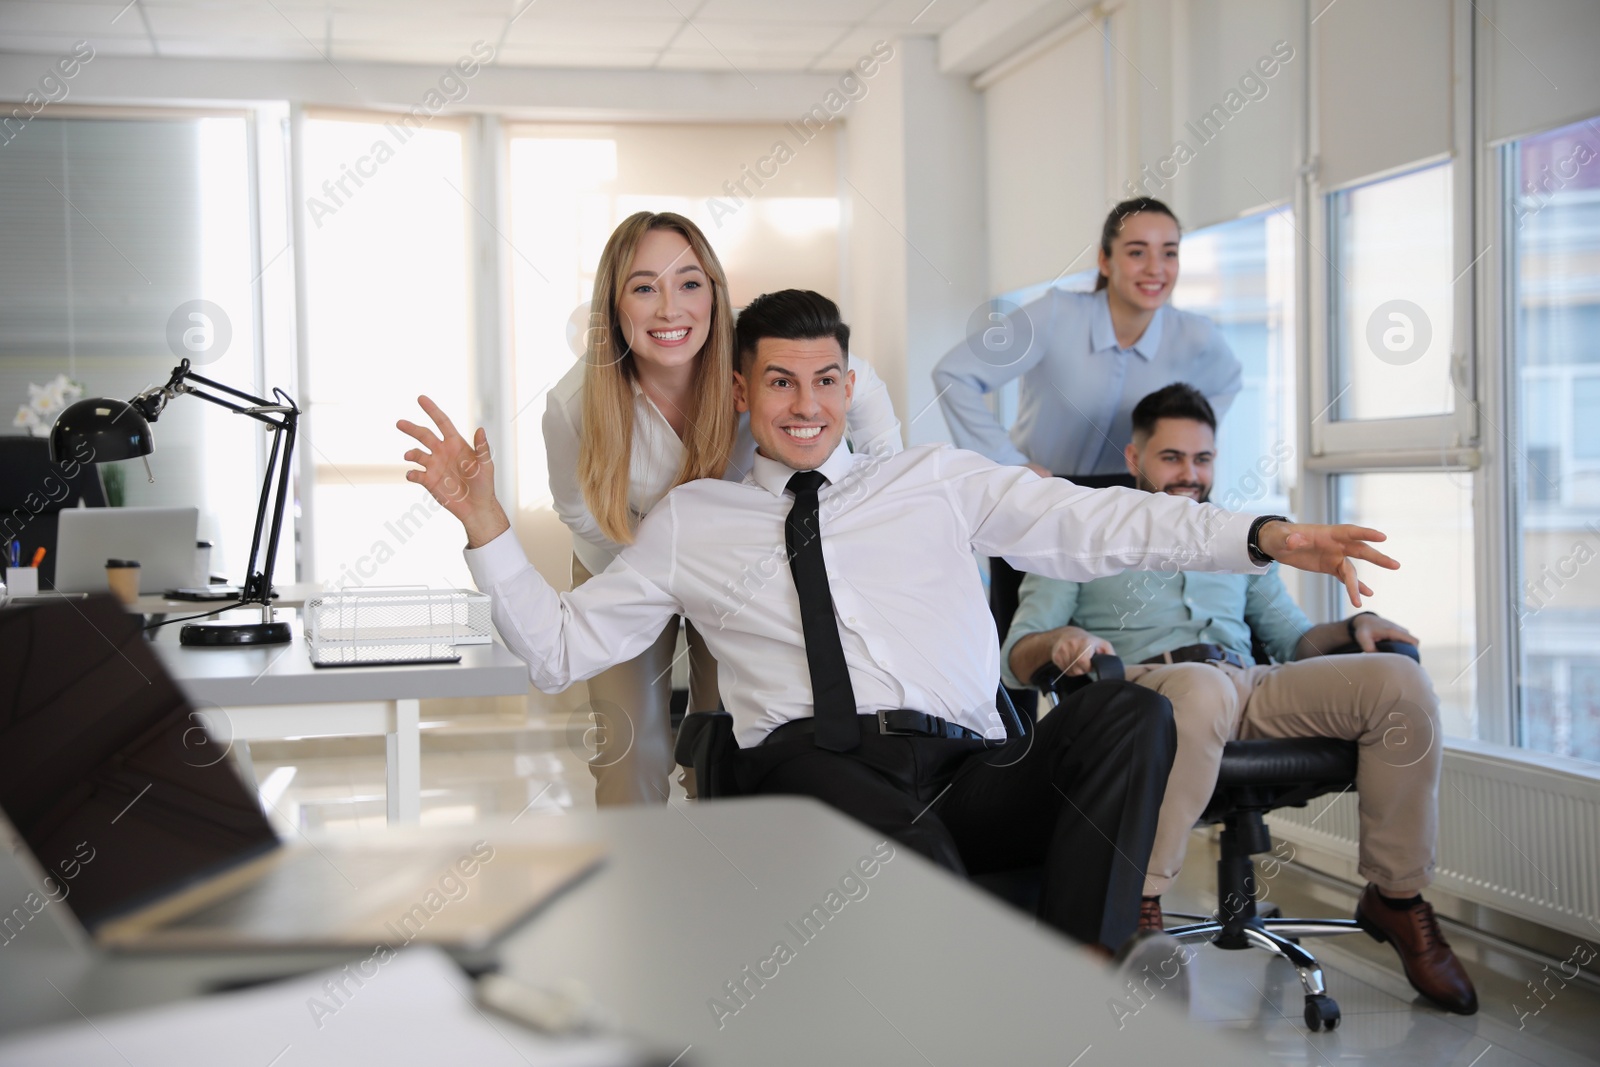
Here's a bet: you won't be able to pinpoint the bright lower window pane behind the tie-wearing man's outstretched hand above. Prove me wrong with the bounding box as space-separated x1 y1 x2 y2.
1334 470 1478 737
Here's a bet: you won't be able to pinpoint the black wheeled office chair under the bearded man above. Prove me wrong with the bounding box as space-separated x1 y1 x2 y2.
1030 641 1418 1032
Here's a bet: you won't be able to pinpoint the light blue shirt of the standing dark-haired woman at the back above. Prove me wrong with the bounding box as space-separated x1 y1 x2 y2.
933 290 1243 477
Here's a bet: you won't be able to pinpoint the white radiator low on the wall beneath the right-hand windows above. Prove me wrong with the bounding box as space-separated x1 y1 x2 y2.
1267 739 1600 937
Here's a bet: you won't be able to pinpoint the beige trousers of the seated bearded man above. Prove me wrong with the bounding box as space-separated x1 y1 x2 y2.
1126 653 1443 896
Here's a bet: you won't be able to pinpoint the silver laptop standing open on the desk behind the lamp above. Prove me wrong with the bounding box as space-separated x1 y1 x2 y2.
56 507 200 593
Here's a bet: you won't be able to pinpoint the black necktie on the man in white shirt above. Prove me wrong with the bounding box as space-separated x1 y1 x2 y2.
784 470 861 752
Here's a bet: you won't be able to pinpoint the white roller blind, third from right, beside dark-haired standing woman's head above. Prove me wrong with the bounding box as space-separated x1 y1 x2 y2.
1177 0 1307 229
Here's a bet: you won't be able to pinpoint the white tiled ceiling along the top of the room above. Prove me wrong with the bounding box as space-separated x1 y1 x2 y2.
0 0 982 72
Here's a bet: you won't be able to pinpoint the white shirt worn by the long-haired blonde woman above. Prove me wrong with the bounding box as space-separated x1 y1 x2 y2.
544 355 901 574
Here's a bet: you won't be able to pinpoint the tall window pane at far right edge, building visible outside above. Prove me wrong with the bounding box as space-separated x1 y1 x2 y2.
1506 112 1600 761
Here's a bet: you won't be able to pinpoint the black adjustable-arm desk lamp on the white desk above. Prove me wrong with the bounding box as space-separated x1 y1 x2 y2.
50 360 299 646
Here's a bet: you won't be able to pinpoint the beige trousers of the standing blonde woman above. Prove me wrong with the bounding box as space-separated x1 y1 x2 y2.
573 555 718 808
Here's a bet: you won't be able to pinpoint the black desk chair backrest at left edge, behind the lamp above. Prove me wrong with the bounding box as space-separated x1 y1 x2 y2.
0 437 106 589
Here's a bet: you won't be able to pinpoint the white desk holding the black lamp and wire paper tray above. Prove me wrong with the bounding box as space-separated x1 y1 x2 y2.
155 608 528 822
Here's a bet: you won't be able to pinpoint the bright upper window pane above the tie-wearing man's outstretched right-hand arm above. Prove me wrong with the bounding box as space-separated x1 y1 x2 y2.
1328 163 1456 421
